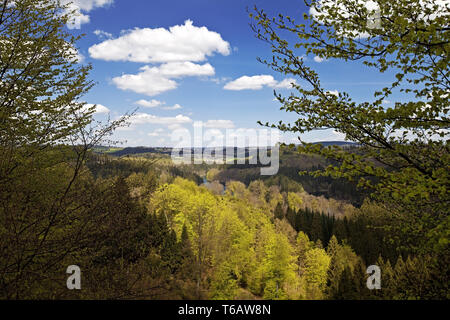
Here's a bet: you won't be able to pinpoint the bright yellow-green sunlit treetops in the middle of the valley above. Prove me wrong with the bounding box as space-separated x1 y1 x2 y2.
150 178 329 299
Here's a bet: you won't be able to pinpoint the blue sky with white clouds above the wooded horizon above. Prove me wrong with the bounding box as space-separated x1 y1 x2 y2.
64 0 400 146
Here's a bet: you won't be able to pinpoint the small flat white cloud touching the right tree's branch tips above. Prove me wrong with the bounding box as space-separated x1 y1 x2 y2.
224 75 295 91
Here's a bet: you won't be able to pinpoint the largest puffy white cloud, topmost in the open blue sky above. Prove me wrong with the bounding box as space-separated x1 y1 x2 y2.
89 20 230 63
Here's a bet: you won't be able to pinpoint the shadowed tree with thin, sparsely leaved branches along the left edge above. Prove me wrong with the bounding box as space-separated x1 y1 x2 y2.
0 0 130 299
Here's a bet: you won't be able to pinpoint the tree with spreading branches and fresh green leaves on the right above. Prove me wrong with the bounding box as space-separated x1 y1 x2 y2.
250 0 450 255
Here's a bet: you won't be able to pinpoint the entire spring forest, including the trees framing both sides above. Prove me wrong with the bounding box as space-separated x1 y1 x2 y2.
0 0 450 300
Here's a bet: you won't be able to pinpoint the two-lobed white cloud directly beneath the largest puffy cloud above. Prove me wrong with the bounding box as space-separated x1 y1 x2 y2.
112 62 214 96
